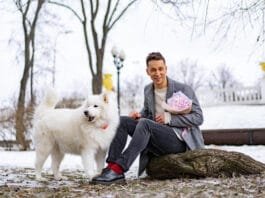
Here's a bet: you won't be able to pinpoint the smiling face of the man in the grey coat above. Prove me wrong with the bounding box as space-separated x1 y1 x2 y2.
146 60 167 88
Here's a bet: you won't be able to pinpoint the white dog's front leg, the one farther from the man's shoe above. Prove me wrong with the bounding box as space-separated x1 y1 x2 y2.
82 150 97 180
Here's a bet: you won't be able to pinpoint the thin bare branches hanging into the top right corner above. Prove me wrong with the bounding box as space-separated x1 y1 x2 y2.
159 0 265 46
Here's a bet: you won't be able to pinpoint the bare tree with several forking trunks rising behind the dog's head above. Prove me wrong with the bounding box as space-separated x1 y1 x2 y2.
49 0 137 94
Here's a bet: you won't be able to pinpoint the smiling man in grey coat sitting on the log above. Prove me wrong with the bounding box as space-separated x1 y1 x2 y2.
91 52 204 184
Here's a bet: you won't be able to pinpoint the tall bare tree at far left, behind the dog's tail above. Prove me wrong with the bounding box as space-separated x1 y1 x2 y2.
14 0 45 150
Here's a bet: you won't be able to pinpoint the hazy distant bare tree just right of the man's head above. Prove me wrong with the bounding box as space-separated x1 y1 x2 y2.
169 59 204 91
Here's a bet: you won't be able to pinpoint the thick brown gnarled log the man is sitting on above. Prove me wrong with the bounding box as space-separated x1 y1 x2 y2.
147 149 265 179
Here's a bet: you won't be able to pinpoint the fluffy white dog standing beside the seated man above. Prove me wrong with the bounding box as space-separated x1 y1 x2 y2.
33 90 119 180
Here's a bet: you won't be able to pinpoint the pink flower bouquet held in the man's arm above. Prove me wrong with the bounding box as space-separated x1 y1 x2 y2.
162 91 192 114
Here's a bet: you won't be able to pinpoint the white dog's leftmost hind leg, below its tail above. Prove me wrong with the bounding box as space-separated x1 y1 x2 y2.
35 147 50 181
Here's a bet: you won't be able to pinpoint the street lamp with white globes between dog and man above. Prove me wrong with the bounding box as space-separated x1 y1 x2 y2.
111 46 125 115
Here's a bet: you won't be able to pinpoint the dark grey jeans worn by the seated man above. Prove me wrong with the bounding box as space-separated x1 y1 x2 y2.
106 116 186 172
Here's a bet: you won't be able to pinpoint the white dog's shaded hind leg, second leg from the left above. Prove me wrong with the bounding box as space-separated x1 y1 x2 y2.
51 145 64 180
